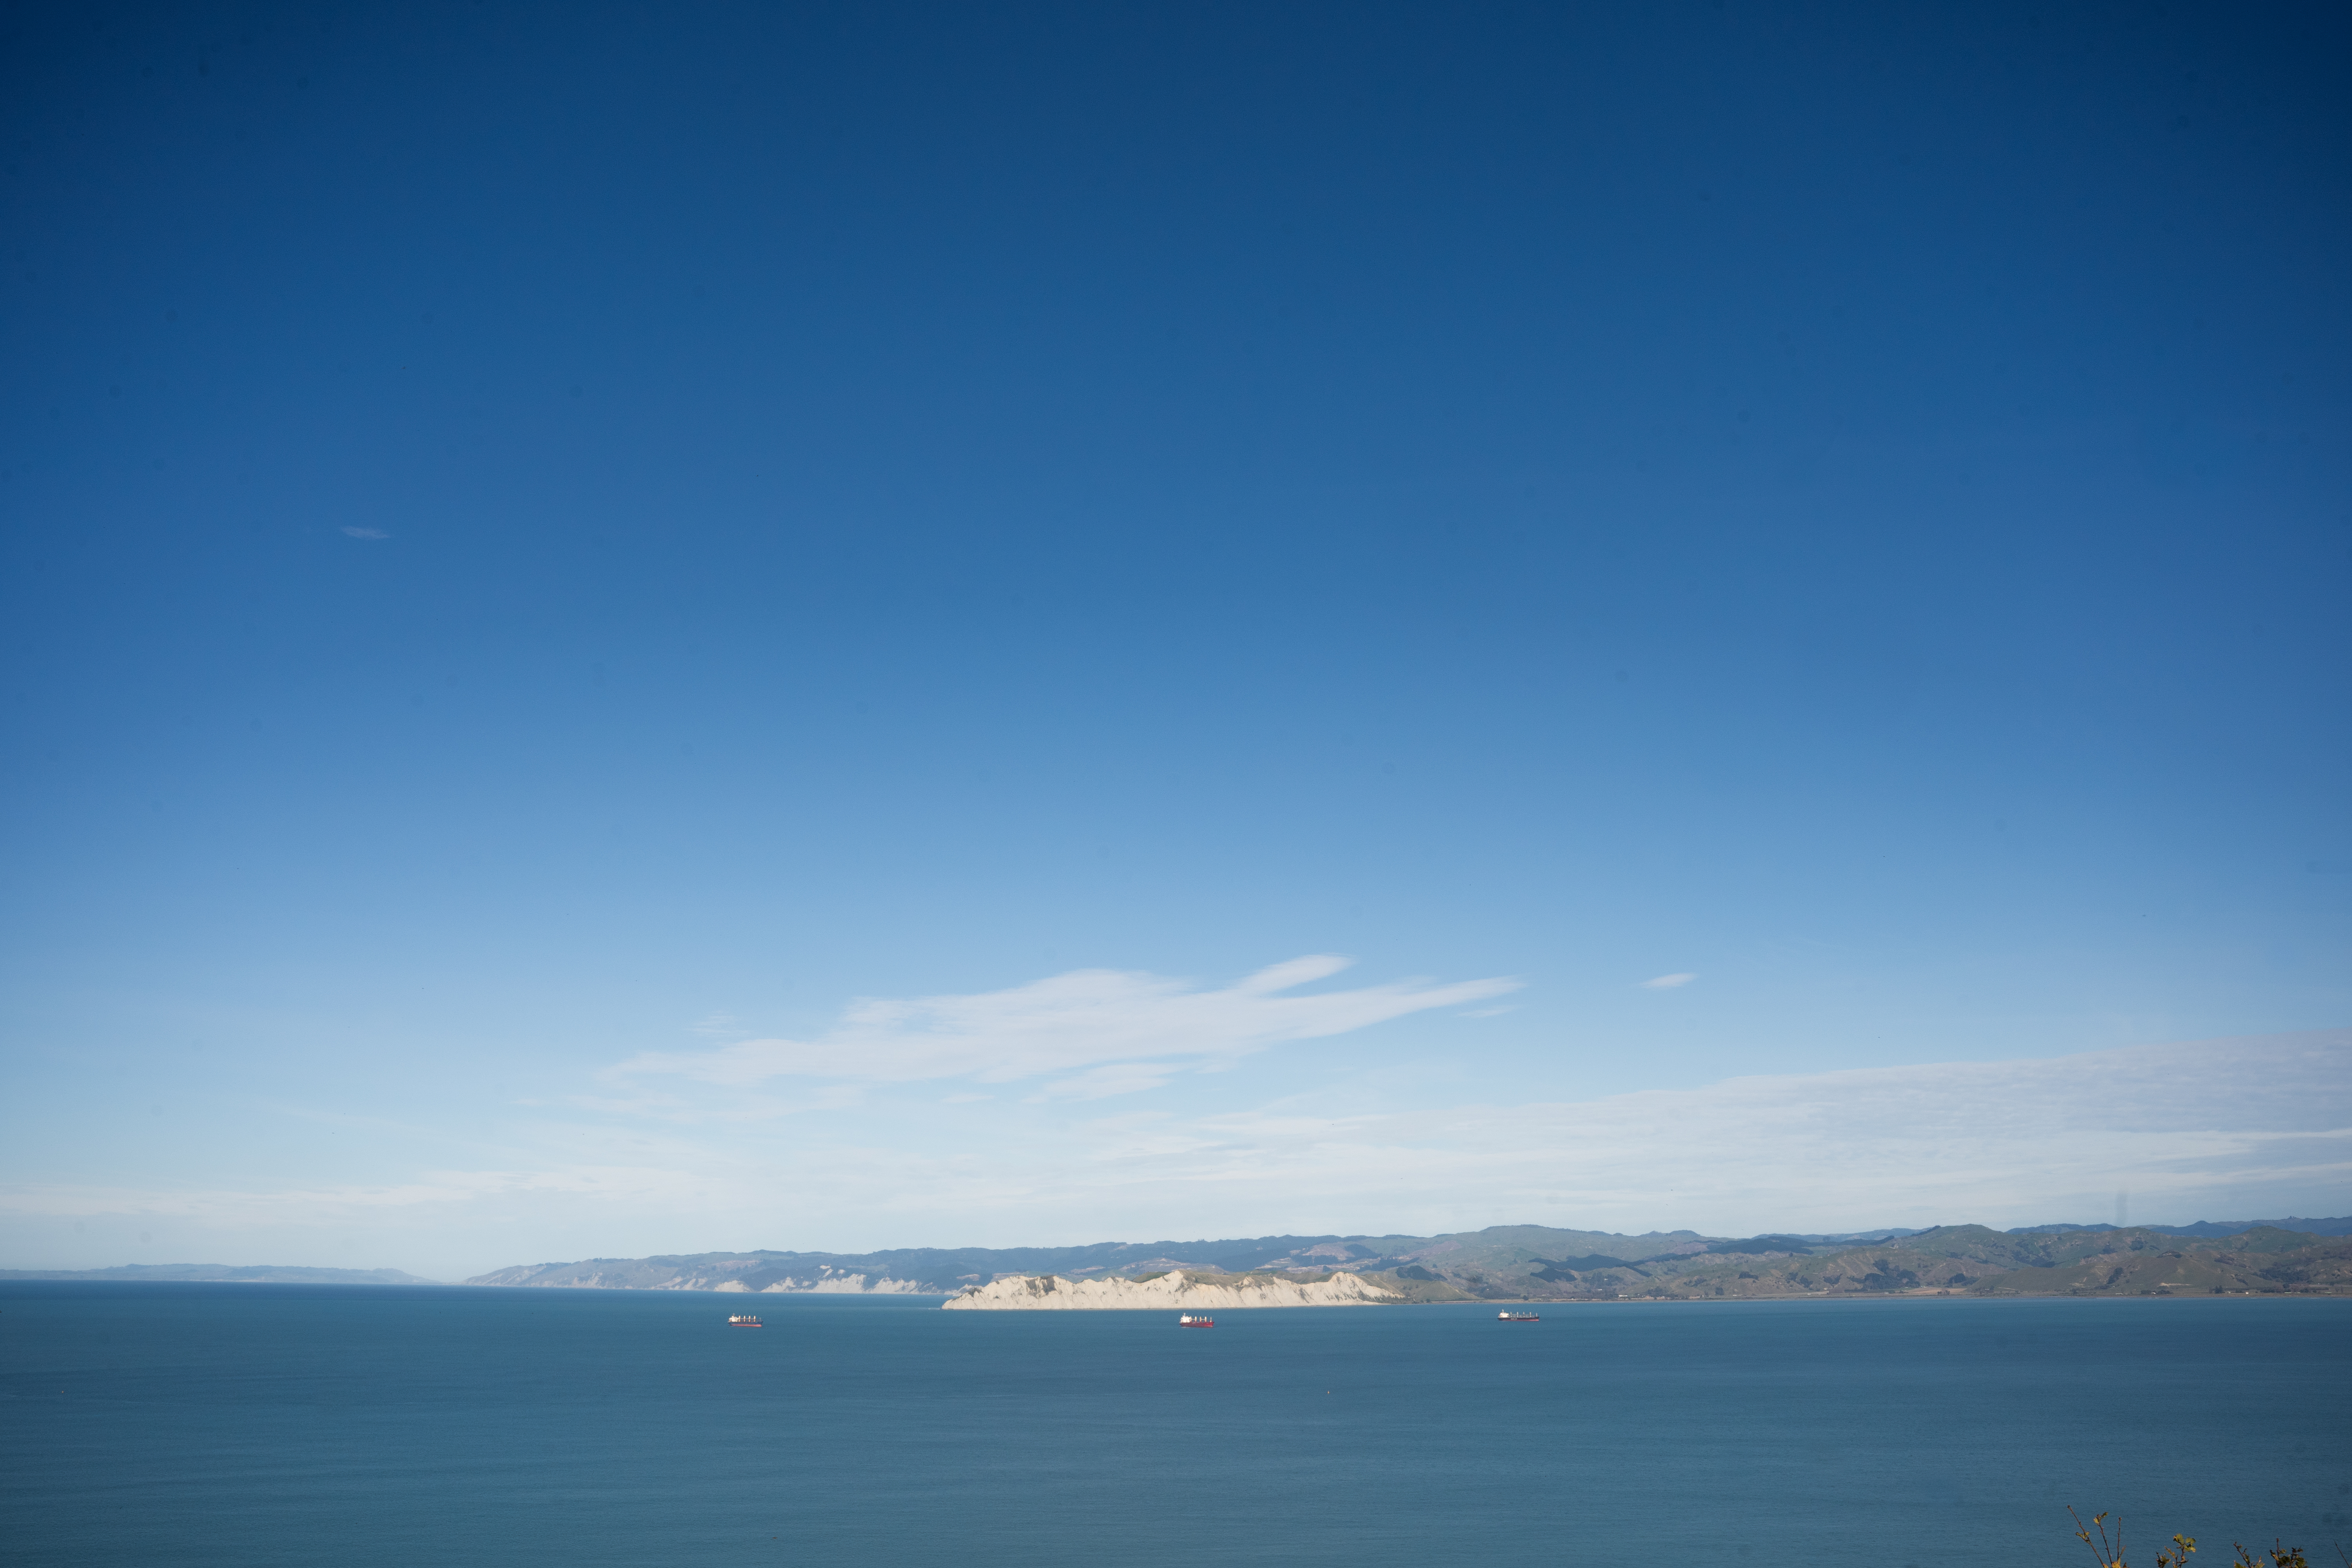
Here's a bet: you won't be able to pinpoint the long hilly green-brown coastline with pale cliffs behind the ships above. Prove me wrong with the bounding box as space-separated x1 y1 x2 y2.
466 1218 2352 1307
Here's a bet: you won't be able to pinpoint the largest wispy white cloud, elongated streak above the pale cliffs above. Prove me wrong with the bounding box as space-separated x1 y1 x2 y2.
607 955 1519 1098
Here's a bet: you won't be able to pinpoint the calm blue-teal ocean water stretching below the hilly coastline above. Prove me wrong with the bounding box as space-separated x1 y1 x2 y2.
0 1283 2352 1568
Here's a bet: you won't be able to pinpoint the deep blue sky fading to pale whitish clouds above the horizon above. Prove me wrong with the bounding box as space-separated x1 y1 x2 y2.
0 2 2352 1274
